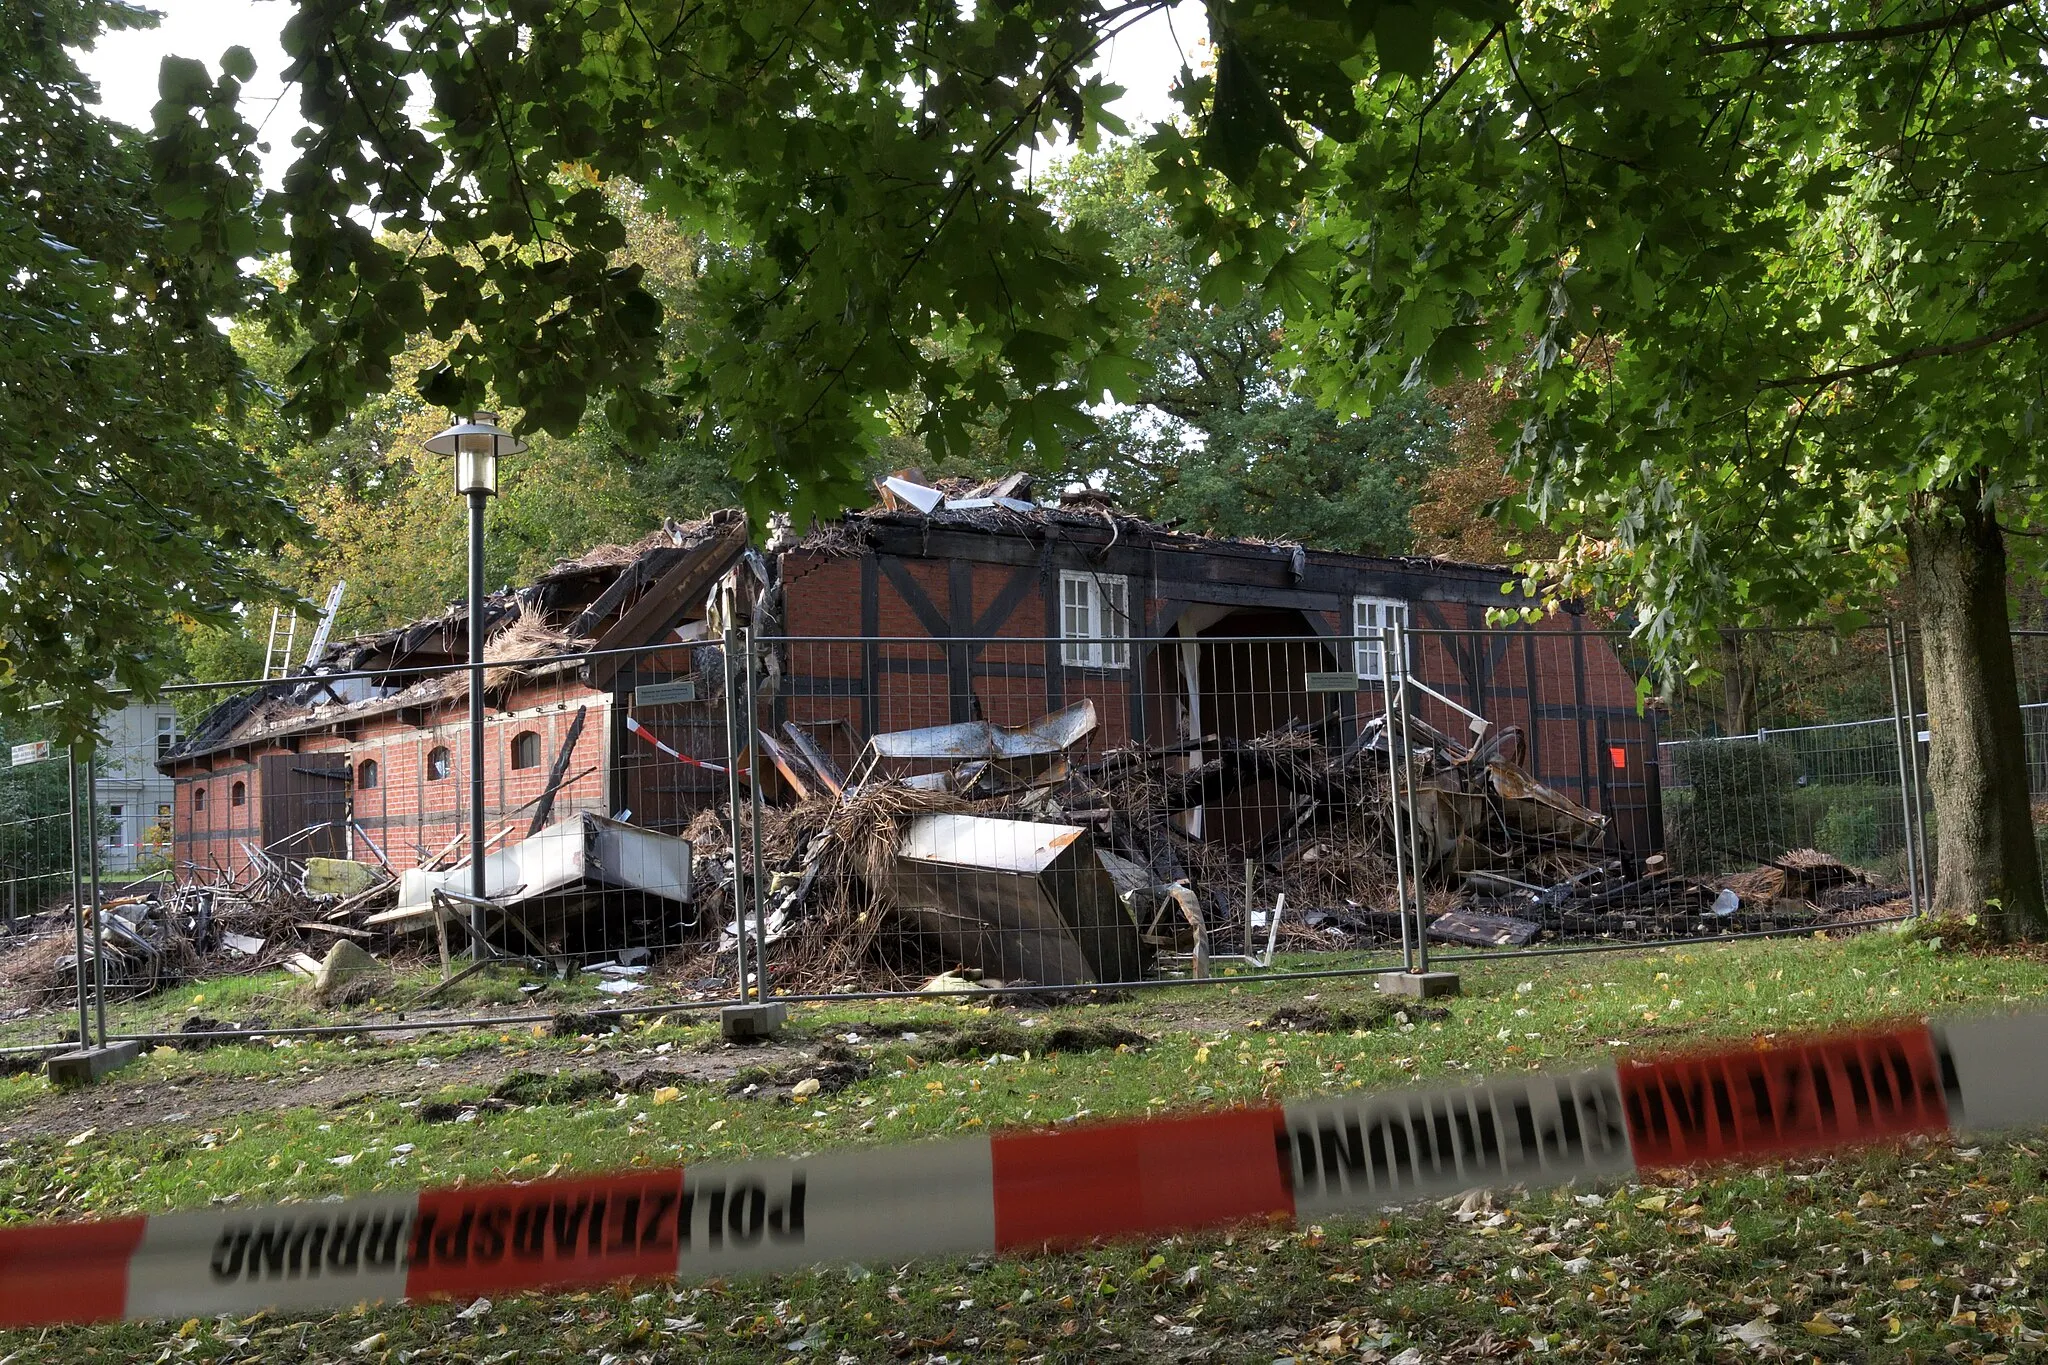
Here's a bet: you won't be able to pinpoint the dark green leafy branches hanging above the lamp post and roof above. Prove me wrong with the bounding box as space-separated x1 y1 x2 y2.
158 0 1157 527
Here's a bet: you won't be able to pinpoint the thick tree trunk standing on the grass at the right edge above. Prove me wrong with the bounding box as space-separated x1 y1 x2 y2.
1907 479 2048 939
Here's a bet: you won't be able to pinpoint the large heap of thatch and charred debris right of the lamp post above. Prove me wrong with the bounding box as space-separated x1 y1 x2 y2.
690 702 1884 990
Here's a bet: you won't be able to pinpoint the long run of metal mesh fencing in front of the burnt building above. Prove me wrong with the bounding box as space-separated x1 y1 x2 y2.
0 612 1957 1055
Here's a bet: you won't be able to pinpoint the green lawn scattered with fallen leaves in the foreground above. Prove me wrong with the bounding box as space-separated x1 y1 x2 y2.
0 933 2048 1365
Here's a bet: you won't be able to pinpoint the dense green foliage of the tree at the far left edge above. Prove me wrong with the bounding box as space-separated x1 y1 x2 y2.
0 0 297 743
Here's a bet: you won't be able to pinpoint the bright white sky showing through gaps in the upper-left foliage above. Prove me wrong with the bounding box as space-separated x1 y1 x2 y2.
80 0 1208 180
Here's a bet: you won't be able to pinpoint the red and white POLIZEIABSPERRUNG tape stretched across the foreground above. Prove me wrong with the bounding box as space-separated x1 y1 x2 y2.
0 1015 2048 1326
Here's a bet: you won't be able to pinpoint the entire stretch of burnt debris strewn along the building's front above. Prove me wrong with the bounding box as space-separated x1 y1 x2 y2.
4 700 1894 997
